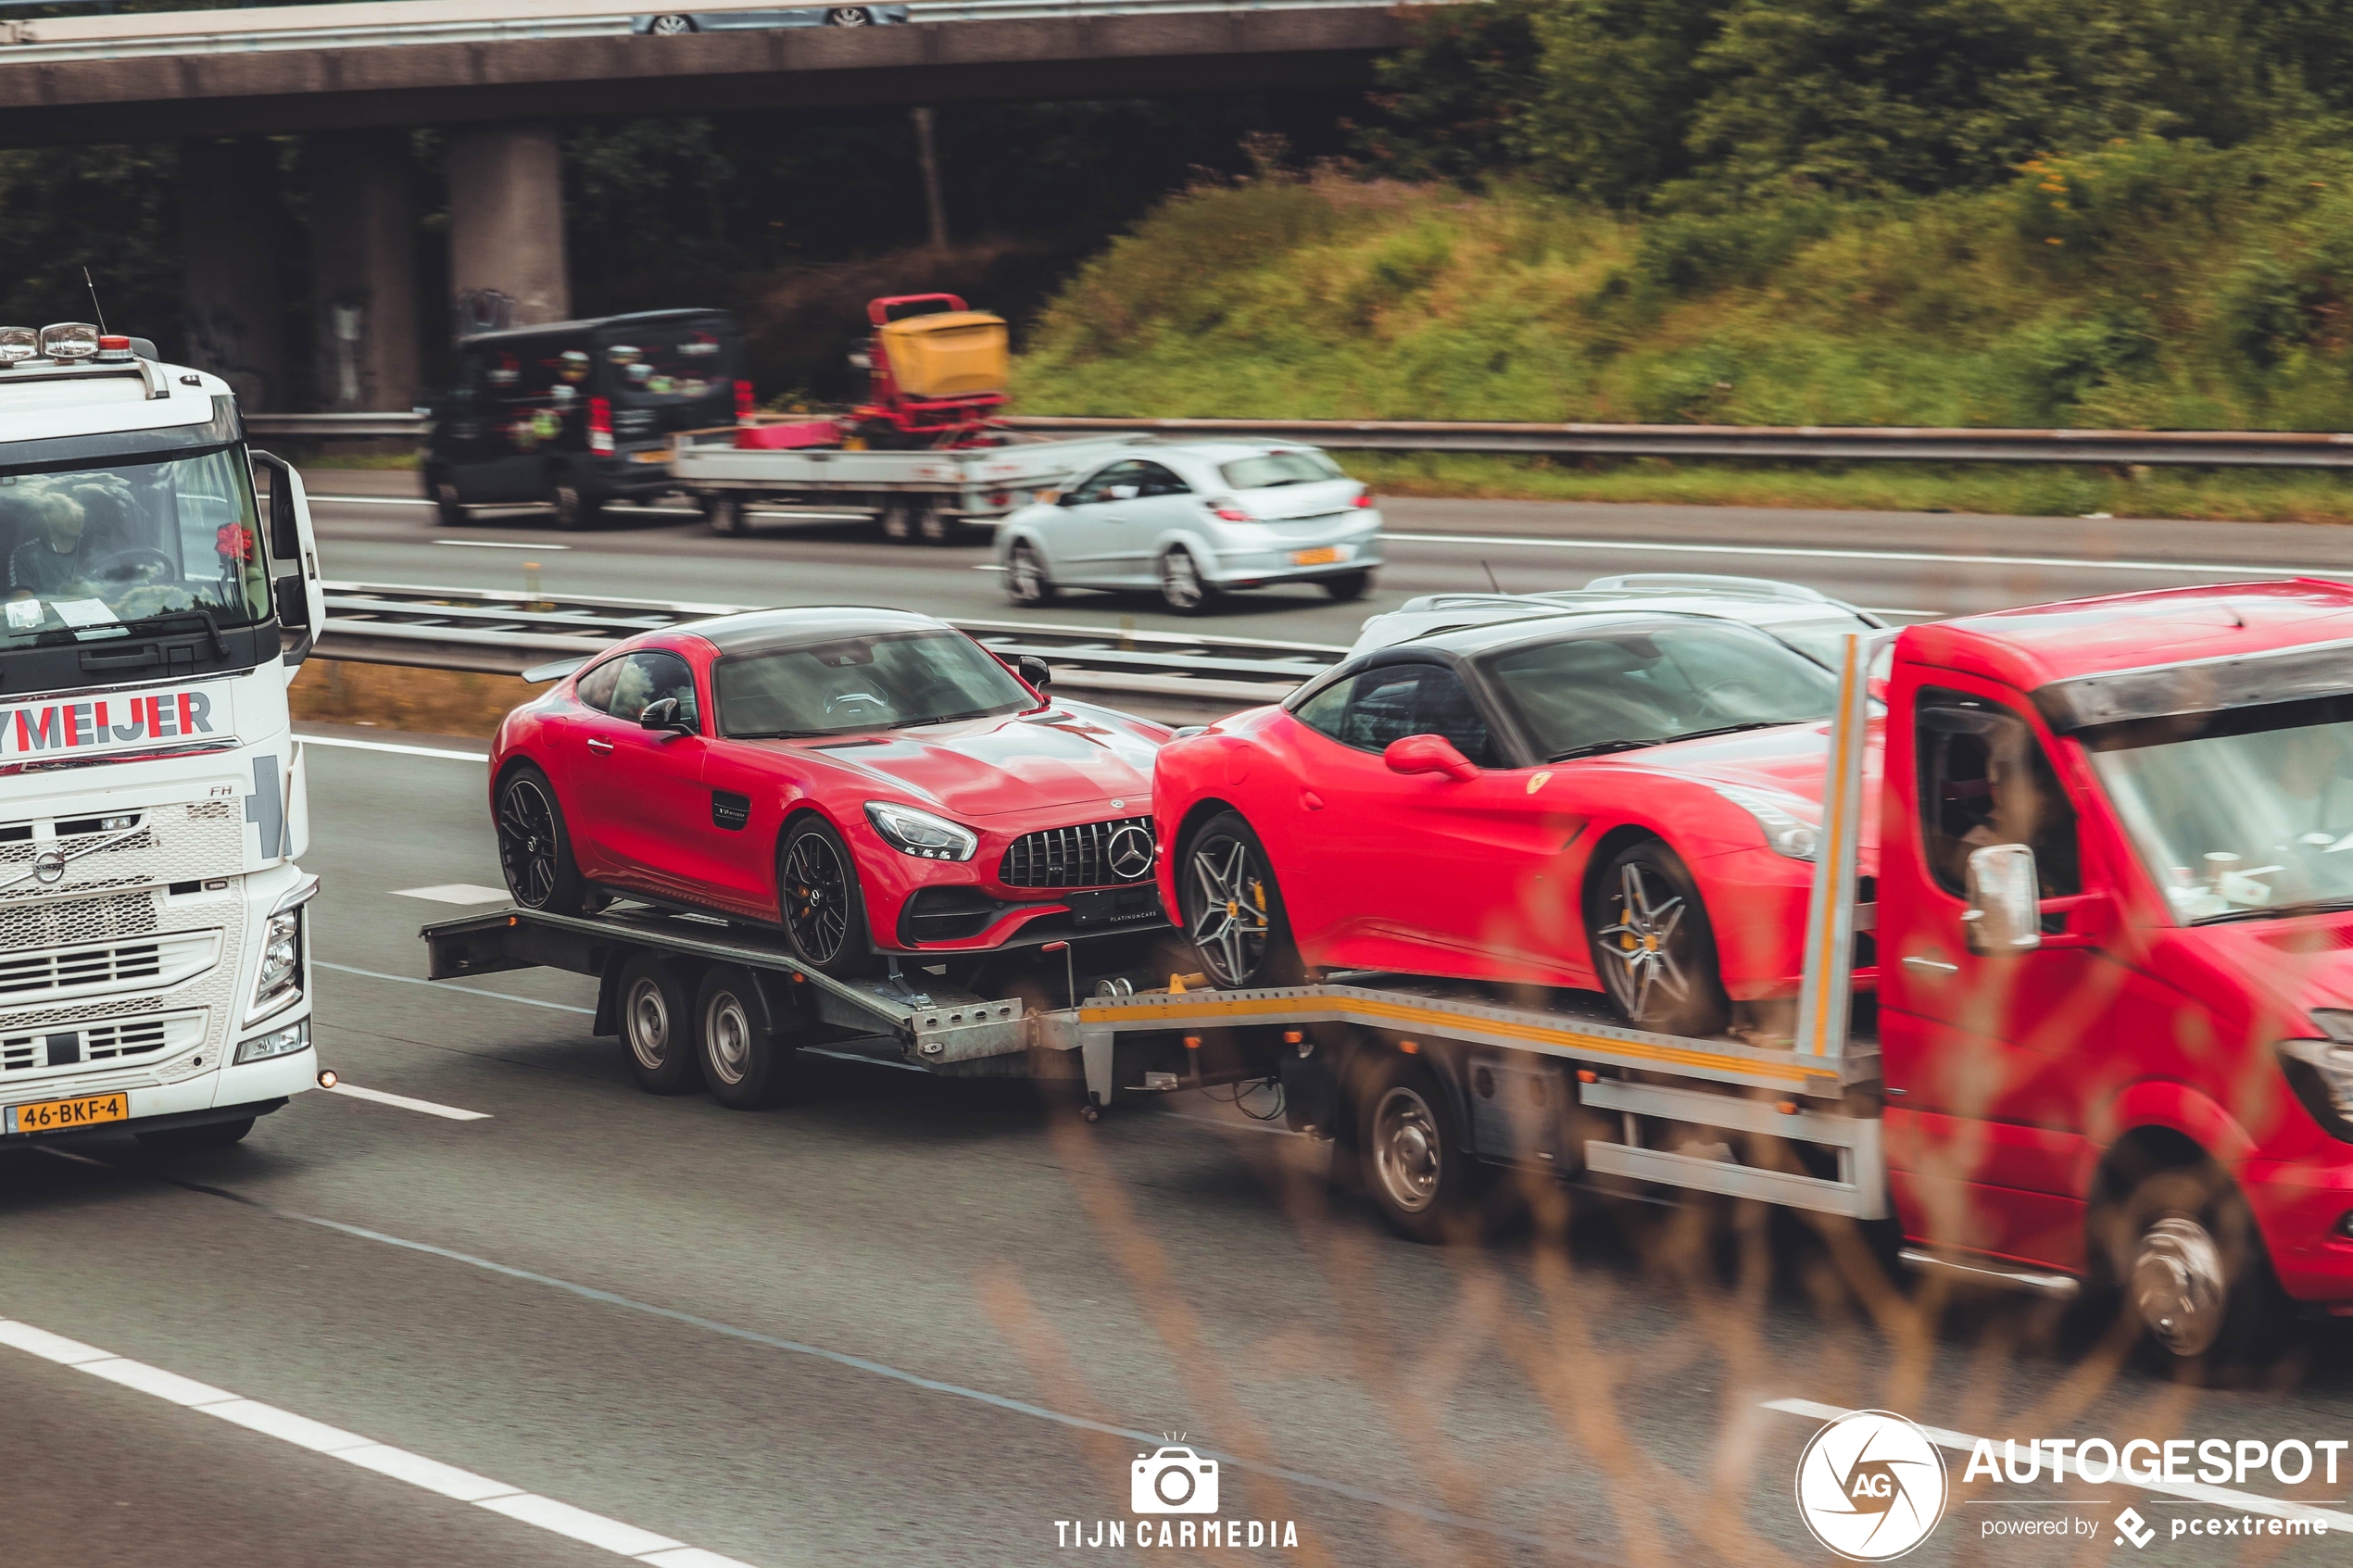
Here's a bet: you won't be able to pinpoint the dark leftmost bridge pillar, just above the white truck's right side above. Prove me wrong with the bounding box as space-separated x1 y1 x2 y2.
179 136 287 409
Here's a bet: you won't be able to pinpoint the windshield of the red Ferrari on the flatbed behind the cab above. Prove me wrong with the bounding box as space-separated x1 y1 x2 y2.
1485 623 1838 761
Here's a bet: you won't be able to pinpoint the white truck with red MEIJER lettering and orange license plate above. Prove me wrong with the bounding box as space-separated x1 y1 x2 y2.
0 322 325 1149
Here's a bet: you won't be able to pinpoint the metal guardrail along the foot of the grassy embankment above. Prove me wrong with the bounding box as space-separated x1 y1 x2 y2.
262 414 2353 468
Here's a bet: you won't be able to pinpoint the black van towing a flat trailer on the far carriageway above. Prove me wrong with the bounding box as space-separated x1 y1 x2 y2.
423 310 750 529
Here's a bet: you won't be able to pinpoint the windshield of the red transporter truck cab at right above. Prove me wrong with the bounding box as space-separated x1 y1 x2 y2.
2082 696 2353 924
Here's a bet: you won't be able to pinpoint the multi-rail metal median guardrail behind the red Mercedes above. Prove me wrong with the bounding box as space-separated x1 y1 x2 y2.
318 583 1348 708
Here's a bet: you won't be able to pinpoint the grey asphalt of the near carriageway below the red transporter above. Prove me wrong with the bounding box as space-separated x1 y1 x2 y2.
0 738 2353 1568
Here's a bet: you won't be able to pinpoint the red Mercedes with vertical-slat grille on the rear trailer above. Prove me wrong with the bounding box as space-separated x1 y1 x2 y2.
489 608 1172 975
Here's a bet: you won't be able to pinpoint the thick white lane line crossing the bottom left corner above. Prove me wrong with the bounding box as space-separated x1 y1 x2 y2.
0 1319 749 1568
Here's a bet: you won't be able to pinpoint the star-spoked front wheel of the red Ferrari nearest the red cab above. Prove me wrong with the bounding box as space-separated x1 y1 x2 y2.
1586 839 1731 1036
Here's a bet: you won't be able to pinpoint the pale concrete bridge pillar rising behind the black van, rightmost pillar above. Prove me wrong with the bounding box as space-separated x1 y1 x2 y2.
447 125 572 332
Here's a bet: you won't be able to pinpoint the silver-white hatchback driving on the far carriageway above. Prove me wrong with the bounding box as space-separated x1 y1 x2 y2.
998 442 1381 616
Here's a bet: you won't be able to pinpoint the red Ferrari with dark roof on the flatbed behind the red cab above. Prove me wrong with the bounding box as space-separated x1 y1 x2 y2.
1153 611 1878 1035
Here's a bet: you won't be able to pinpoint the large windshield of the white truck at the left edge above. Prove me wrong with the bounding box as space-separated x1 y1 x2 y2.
0 446 271 646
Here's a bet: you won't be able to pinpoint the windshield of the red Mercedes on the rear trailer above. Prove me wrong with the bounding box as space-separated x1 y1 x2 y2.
713 633 1038 738
